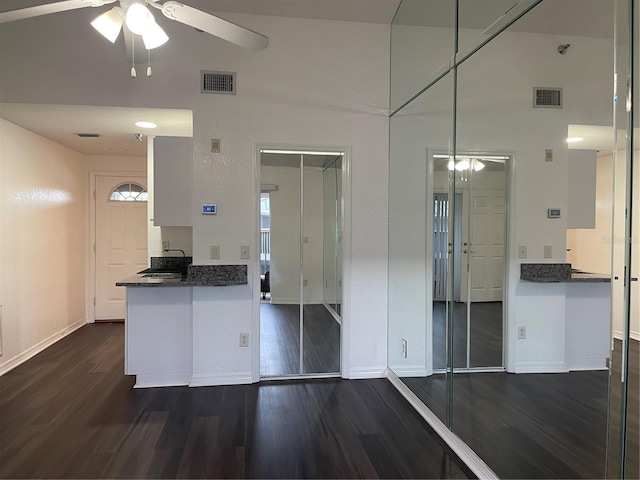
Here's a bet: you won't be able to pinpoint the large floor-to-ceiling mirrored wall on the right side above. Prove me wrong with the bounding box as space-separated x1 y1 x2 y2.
388 0 640 478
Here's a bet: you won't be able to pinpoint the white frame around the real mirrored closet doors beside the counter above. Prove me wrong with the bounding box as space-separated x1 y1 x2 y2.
249 143 351 382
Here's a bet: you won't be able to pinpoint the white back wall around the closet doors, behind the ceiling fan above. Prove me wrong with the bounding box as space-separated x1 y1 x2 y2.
0 9 389 377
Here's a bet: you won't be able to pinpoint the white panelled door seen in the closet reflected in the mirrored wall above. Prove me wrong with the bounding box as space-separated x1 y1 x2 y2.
469 190 505 302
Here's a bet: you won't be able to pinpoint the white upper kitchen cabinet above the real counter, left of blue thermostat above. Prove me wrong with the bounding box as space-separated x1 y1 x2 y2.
153 137 193 227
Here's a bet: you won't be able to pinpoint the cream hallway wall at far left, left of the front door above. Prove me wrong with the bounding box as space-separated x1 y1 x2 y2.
0 119 88 373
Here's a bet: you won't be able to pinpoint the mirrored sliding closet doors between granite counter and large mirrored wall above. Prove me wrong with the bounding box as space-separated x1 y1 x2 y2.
259 149 344 380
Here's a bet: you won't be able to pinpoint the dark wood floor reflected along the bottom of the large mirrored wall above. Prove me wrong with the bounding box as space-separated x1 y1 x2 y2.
402 341 639 478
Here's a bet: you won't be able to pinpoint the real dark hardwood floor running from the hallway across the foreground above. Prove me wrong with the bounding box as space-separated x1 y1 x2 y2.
0 324 468 478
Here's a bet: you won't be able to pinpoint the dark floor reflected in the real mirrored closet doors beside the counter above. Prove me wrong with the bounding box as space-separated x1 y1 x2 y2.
260 303 340 376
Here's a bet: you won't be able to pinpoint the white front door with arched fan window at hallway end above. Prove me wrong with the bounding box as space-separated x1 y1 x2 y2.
95 176 147 320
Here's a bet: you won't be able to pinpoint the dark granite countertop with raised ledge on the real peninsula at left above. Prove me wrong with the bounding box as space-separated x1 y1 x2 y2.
116 265 248 287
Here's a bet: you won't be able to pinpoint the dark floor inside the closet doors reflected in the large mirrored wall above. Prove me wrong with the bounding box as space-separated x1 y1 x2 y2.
433 302 502 369
